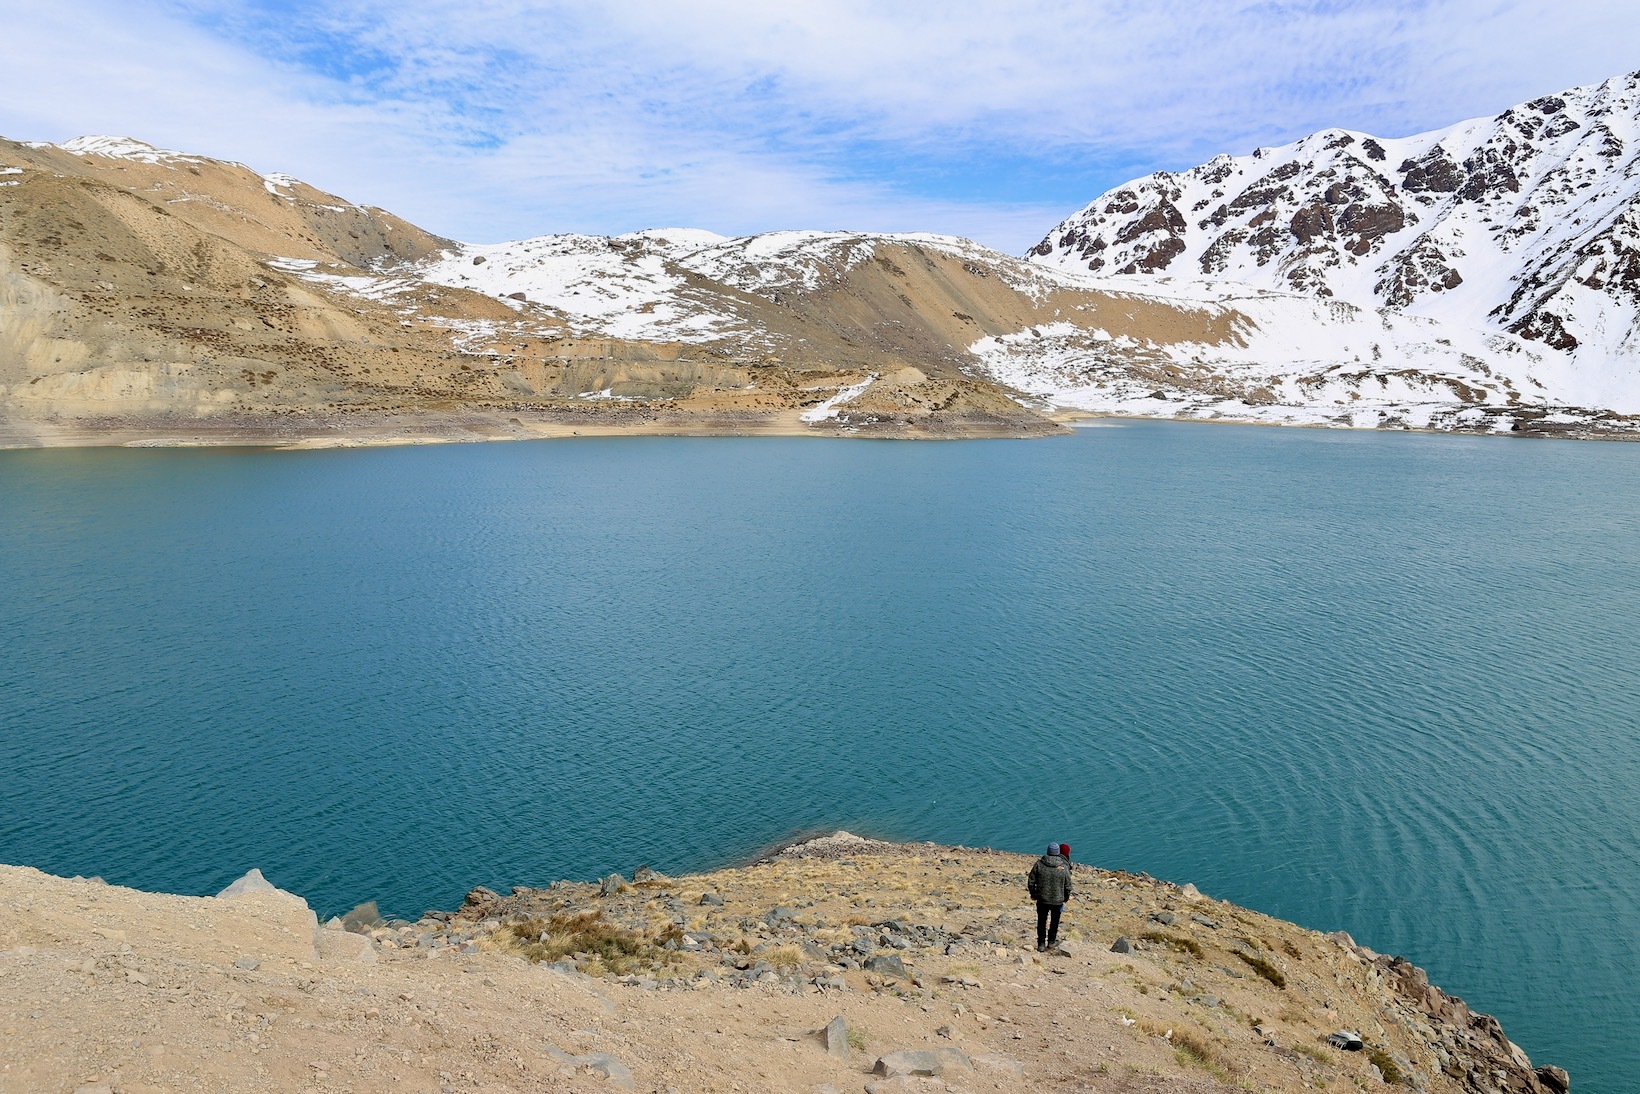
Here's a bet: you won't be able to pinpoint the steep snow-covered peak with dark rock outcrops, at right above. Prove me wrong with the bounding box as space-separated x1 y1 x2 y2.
1030 72 1640 426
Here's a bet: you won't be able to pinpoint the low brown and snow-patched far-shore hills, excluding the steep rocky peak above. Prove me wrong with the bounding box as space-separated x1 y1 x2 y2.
0 107 1640 446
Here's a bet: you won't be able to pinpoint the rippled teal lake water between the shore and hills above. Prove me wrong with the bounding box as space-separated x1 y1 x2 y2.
0 423 1640 1092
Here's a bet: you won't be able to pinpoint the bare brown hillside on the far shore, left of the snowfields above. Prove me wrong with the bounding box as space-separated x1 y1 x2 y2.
0 141 1082 444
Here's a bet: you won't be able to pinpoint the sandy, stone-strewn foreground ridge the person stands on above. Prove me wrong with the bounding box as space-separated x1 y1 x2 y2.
0 833 1568 1094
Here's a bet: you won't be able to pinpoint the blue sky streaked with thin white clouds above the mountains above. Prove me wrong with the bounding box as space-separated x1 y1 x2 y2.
0 0 1640 253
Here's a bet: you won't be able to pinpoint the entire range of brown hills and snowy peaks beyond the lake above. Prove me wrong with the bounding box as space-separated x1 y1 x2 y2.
0 114 1640 446
